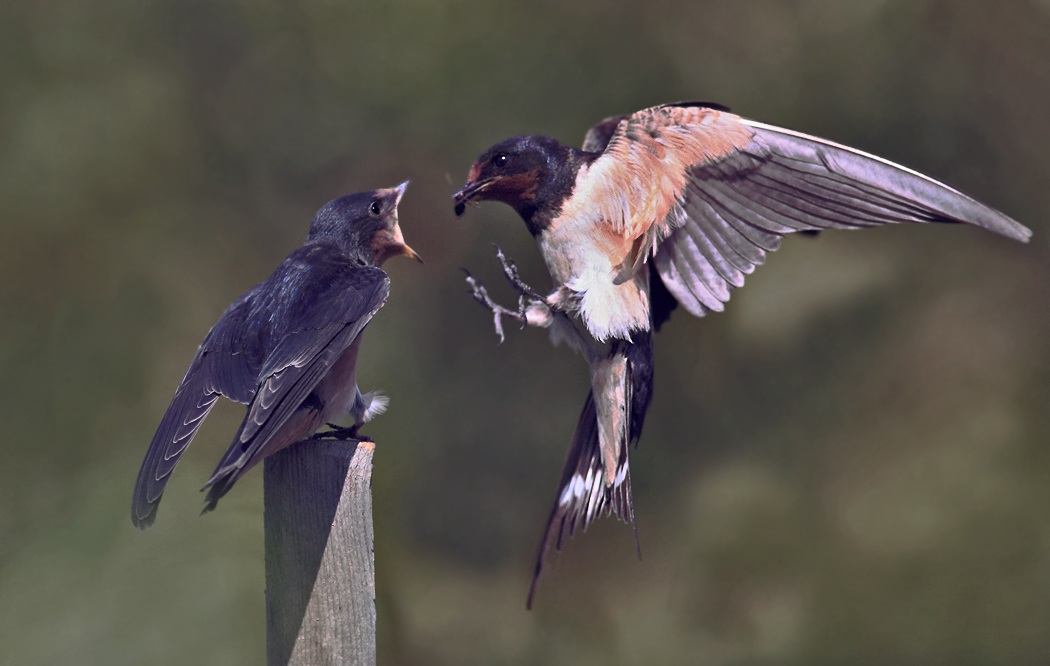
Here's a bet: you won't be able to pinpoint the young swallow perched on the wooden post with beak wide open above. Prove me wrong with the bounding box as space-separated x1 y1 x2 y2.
131 181 422 529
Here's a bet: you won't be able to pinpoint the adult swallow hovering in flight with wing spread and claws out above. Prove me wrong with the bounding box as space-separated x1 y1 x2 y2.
454 102 1031 606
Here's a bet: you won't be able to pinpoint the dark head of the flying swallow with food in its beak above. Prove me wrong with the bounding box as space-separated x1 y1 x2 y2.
453 137 571 222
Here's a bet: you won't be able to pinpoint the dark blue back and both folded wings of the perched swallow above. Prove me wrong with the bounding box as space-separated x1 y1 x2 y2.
131 244 390 528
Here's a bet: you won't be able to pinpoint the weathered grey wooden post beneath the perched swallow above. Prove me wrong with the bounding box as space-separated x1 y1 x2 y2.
263 439 376 666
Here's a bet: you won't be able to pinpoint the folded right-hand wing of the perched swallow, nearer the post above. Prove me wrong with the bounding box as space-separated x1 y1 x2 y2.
205 253 390 502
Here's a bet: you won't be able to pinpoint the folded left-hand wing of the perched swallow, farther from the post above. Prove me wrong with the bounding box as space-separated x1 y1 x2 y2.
131 286 259 529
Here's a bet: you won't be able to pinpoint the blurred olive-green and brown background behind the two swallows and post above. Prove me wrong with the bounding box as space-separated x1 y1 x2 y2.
0 0 1050 665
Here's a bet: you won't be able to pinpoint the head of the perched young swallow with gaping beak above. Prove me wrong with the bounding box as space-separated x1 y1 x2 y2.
309 181 423 266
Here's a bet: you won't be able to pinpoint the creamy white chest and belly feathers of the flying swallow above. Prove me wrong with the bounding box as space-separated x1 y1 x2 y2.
540 216 649 341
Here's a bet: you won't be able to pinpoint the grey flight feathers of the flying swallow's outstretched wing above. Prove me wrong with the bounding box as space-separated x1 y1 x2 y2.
638 106 1031 315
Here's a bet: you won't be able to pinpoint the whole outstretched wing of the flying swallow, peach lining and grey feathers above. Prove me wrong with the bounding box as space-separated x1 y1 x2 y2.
588 103 1031 315
